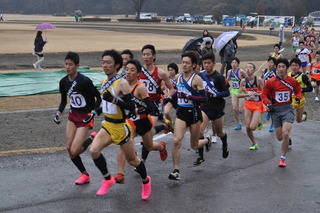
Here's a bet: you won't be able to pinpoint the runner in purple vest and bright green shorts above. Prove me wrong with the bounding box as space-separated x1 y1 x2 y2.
227 57 247 130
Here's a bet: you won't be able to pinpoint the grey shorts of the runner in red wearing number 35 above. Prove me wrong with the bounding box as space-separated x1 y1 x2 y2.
271 104 294 128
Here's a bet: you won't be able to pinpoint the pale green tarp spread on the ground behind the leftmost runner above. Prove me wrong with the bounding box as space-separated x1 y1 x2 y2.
0 68 106 97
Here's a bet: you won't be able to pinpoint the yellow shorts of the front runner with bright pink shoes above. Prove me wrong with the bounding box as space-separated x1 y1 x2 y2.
102 121 131 145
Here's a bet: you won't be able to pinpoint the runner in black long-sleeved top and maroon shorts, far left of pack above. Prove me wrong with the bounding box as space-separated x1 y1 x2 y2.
54 52 101 185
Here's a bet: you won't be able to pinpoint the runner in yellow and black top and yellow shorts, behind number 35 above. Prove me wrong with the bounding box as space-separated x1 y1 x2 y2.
288 58 312 123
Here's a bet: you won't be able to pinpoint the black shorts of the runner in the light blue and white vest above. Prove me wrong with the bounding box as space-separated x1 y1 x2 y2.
177 107 202 126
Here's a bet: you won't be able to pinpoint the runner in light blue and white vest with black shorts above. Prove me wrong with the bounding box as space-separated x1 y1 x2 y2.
165 52 211 180
